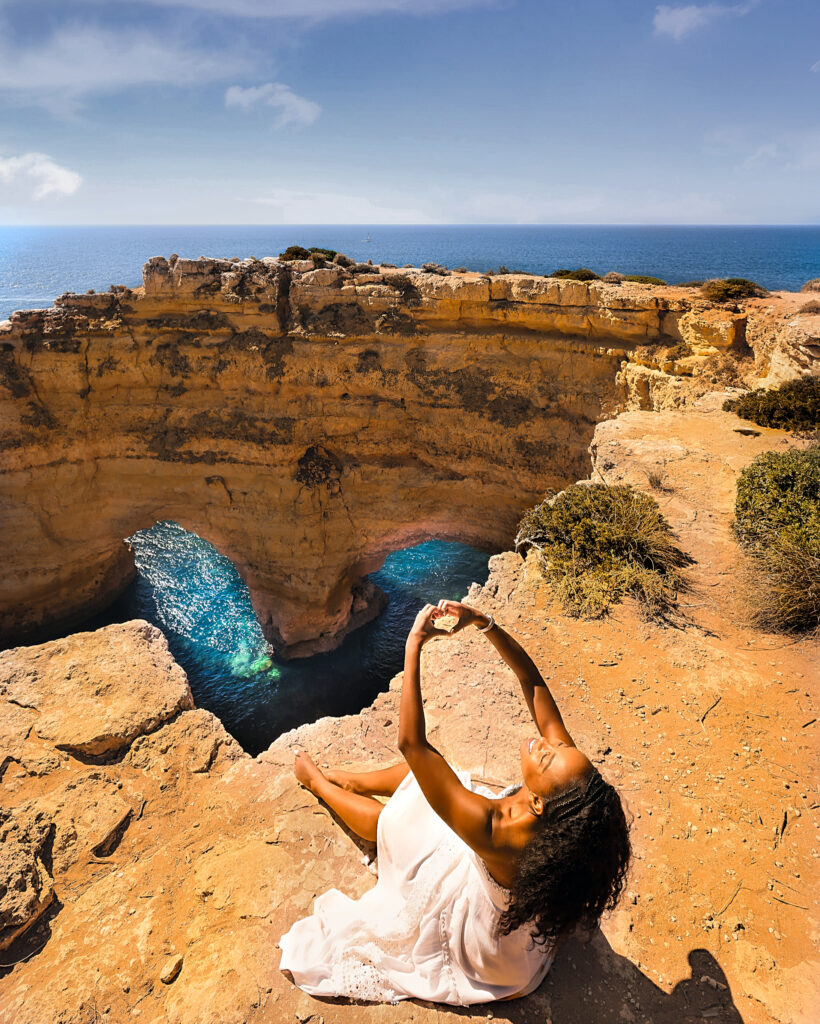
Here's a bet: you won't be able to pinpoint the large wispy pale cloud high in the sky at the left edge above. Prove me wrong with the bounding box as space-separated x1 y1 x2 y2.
0 26 247 114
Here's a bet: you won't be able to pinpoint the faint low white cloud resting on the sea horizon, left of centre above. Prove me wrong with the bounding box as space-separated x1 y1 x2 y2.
251 188 433 224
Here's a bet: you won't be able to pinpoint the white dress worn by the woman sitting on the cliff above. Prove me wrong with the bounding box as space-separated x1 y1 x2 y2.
279 772 552 1006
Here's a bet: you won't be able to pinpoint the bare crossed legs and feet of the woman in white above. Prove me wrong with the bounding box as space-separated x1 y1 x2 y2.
294 751 409 843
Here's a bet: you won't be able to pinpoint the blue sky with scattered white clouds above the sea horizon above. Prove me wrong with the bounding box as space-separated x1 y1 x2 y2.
0 0 820 224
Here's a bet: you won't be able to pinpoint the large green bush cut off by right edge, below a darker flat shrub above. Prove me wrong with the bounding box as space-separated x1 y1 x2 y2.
732 444 820 632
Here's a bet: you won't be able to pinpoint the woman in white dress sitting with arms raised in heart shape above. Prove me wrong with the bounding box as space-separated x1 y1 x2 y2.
279 601 630 1006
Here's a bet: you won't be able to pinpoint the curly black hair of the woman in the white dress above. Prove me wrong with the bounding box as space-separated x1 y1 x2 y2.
499 769 632 944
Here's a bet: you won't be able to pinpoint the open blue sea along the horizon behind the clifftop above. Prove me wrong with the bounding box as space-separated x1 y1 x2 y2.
0 225 820 319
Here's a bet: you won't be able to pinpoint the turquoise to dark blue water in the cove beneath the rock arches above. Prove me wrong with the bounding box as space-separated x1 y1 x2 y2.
91 522 488 754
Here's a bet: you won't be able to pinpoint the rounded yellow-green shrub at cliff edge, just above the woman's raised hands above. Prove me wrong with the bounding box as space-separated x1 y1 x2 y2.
515 483 690 618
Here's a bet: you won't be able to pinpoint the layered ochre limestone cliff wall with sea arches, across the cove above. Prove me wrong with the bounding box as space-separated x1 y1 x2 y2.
0 257 810 655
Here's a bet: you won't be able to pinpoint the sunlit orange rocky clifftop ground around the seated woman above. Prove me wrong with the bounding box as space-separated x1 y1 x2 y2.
0 395 820 1024
